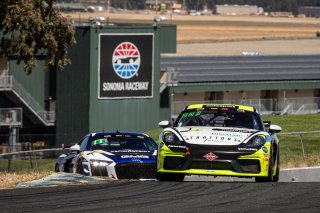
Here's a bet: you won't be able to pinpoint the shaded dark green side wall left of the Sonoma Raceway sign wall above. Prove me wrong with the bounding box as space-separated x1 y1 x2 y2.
56 28 91 145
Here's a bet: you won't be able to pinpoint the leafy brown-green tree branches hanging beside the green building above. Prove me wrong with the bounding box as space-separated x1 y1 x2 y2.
0 0 76 73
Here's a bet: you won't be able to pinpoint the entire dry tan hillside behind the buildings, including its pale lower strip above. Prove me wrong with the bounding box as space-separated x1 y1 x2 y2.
64 11 320 55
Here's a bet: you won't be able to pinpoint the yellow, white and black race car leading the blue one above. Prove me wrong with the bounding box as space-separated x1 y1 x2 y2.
156 104 281 182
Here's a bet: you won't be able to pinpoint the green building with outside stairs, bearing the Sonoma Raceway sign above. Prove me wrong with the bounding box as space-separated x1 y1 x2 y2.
0 24 176 147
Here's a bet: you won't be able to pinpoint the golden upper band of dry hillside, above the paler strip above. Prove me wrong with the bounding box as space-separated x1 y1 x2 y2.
65 12 320 43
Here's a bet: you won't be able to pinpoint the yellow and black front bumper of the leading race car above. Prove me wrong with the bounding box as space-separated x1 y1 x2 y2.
157 143 270 177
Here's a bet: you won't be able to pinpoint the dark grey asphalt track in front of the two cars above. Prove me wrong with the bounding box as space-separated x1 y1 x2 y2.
0 181 320 213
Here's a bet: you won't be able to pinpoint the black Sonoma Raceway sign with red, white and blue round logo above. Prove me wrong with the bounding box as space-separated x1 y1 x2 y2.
98 34 154 99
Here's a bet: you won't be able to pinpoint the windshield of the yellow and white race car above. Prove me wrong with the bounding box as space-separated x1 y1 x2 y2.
175 108 263 130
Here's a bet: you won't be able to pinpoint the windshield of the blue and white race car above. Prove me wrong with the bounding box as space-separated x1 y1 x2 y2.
91 134 157 152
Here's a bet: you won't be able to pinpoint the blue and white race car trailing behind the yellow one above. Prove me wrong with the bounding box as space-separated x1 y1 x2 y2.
55 132 157 179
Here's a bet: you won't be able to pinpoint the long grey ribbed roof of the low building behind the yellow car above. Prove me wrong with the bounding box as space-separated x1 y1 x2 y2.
161 55 320 83
